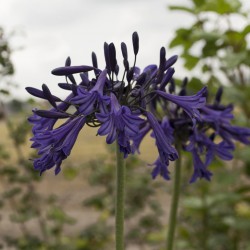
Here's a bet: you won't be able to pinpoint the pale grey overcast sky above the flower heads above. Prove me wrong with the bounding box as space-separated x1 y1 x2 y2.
0 0 250 98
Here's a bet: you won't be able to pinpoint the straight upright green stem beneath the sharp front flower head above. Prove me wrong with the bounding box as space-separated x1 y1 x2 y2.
115 143 125 250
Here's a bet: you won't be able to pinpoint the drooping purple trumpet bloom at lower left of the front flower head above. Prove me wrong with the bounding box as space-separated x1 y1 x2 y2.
31 116 85 174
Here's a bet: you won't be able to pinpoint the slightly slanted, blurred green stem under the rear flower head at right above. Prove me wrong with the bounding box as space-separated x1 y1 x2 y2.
166 147 181 250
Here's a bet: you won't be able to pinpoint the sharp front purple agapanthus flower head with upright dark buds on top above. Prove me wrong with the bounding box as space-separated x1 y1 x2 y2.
26 32 206 176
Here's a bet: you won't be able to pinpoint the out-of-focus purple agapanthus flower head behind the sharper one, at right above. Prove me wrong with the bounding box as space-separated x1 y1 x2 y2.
147 79 250 182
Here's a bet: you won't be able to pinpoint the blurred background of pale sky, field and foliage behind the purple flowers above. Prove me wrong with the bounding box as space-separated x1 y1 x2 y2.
0 0 250 250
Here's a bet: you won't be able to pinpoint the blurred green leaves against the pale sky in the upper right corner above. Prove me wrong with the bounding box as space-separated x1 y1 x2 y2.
169 0 250 88
